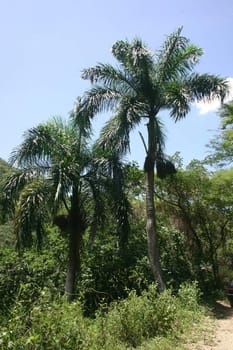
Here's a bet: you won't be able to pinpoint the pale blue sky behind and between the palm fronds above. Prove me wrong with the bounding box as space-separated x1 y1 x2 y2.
0 0 233 164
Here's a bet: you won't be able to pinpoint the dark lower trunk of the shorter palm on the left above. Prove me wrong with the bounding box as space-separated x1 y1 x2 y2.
65 227 82 301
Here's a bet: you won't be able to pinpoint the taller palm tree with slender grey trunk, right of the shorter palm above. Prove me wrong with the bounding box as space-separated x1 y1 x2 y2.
82 28 228 290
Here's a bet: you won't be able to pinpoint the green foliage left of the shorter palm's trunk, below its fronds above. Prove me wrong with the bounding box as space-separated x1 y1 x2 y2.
0 229 66 317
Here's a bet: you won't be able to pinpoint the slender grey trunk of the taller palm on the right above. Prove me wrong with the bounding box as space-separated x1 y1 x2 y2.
144 116 166 291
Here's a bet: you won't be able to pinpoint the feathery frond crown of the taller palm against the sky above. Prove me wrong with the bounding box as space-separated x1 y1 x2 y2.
82 28 227 157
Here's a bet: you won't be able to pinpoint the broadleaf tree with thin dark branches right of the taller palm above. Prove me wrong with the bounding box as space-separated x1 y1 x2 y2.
156 160 233 288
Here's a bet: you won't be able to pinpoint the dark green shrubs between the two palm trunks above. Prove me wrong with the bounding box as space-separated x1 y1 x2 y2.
78 222 153 315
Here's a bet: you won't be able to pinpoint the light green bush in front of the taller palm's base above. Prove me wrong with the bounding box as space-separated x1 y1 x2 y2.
101 286 177 347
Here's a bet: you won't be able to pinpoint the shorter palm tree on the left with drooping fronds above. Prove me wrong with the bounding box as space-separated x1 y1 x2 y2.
5 98 129 301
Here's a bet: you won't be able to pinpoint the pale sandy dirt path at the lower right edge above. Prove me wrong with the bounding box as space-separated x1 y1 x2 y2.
190 302 233 350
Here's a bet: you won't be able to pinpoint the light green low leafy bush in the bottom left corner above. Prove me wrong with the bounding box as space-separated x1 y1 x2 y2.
1 290 93 350
